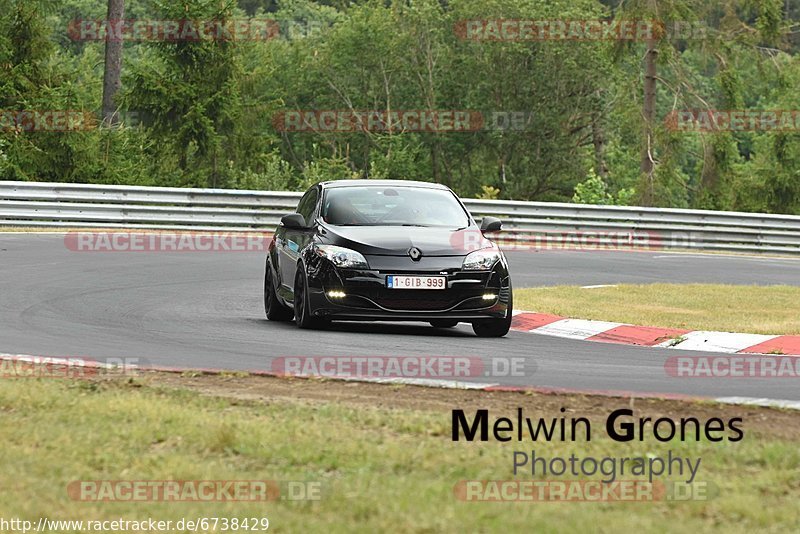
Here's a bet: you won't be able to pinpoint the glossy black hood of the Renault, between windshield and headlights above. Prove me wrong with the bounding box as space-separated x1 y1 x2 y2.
322 225 480 257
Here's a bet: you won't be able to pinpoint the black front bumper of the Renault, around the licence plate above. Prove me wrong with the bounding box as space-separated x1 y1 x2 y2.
308 257 511 321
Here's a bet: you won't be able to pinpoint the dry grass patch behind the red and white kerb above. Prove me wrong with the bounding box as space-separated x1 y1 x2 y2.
514 284 800 334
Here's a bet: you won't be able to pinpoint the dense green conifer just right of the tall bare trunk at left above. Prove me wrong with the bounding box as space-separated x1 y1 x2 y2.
125 0 242 187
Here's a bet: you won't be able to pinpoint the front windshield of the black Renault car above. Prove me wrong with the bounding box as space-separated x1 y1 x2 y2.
322 186 469 229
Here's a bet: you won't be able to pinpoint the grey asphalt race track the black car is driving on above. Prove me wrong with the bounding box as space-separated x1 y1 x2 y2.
0 233 800 400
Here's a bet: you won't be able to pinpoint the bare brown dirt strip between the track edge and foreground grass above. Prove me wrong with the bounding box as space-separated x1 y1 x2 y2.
125 372 800 439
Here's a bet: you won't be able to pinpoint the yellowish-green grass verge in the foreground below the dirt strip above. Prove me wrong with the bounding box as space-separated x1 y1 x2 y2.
0 379 800 532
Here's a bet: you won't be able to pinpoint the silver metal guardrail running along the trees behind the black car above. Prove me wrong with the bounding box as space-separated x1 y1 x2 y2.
0 181 800 254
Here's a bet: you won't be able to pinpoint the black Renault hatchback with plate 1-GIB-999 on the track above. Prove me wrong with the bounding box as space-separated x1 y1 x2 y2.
264 180 512 337
